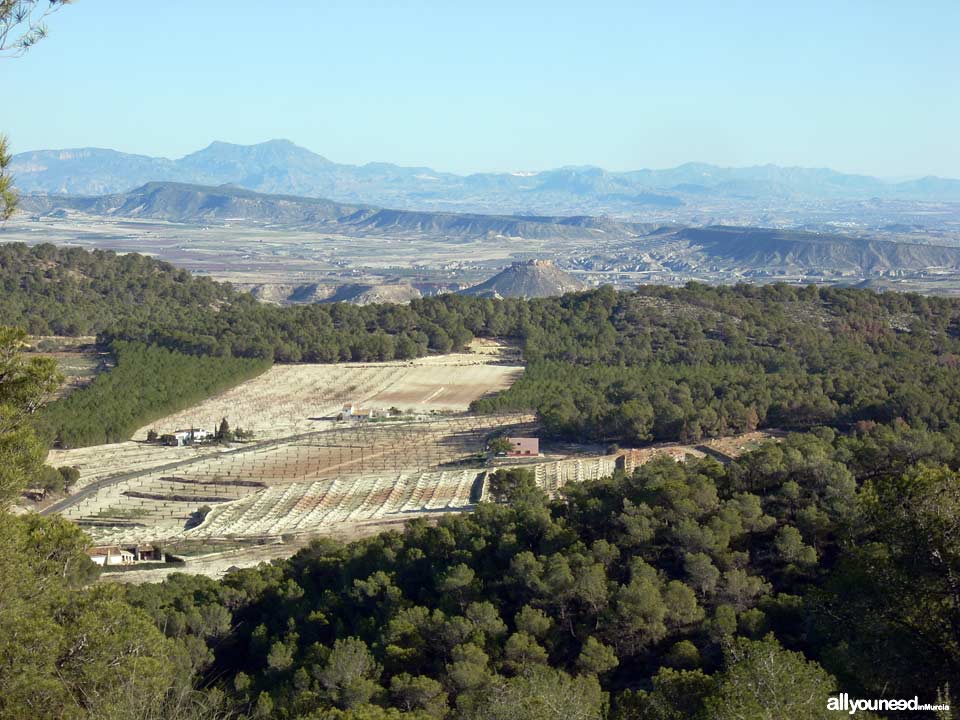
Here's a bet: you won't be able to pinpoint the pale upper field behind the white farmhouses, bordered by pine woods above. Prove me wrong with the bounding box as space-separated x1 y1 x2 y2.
134 353 523 440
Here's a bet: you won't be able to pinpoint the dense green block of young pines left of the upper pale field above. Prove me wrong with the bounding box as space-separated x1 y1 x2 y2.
35 341 270 448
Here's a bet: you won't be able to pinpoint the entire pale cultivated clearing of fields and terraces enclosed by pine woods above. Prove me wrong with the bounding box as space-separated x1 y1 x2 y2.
44 334 780 579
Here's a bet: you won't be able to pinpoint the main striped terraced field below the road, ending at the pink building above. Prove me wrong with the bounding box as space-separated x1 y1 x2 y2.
63 415 532 542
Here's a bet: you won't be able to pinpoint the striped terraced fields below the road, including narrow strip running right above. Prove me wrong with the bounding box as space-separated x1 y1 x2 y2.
64 428 771 543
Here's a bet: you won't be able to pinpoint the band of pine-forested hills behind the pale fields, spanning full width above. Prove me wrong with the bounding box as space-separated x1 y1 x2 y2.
9 246 960 444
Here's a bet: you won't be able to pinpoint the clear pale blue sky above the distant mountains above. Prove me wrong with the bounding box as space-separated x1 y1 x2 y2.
0 0 960 179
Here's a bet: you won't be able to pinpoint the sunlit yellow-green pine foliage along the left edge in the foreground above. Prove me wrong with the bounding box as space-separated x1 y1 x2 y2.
0 329 220 720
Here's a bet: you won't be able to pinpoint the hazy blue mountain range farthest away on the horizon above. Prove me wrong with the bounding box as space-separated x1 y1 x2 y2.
11 140 960 214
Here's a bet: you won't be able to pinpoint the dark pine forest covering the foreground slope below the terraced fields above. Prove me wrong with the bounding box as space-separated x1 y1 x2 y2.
112 423 960 720
